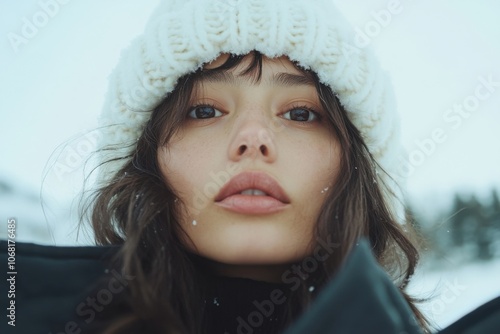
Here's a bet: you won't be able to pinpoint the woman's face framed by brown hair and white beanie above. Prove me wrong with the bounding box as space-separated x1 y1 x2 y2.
158 55 340 280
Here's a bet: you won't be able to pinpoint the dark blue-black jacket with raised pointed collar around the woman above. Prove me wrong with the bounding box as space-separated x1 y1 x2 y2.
0 241 500 334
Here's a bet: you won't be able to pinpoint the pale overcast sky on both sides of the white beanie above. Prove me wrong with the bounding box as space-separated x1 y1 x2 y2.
0 0 500 209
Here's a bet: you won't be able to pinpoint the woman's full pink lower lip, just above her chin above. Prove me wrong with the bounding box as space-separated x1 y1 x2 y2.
216 194 288 214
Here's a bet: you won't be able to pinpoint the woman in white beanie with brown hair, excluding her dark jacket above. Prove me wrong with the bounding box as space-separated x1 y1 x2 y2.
82 0 426 333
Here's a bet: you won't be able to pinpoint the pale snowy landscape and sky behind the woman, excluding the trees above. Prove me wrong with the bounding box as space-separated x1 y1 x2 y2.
0 0 500 326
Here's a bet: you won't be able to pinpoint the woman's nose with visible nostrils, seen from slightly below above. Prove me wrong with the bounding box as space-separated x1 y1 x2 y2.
229 120 277 162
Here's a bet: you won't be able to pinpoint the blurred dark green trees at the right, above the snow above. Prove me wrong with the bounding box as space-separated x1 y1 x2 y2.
409 189 500 262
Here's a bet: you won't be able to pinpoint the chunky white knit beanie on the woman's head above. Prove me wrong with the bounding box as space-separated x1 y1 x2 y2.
99 0 404 221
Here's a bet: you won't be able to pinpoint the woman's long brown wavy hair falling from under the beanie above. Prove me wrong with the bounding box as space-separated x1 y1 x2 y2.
82 51 429 334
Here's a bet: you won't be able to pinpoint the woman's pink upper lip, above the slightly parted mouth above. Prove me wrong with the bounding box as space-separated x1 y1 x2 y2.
215 172 290 203
